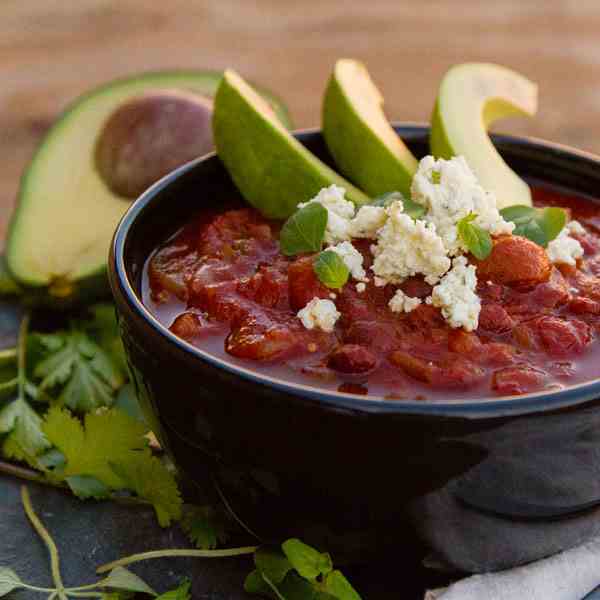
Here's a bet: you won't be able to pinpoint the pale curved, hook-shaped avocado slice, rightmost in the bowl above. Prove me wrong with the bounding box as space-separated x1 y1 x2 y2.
430 63 537 208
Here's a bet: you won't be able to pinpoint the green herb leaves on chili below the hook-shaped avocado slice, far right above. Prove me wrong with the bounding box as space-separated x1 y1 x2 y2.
500 204 567 248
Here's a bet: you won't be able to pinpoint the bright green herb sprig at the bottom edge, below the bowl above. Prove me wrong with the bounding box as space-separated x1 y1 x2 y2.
244 538 360 600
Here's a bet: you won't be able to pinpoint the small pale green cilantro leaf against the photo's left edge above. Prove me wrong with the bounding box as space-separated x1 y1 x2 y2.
0 398 51 466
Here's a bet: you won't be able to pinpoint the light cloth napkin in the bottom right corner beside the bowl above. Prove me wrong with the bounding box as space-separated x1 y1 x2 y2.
425 536 600 600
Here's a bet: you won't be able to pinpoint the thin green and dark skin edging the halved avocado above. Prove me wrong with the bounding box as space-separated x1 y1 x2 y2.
5 70 293 311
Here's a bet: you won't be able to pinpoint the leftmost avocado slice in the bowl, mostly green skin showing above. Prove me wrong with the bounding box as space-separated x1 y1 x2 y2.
213 70 369 219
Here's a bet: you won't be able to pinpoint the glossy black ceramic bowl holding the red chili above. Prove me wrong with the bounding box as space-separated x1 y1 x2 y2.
110 125 600 571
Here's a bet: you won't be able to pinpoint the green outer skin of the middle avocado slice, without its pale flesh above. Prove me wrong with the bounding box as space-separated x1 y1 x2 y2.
322 74 414 197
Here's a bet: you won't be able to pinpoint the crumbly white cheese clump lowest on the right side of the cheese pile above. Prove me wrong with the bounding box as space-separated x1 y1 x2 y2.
428 256 481 331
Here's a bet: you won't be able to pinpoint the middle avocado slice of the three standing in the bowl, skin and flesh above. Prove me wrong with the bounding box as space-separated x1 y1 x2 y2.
323 59 418 197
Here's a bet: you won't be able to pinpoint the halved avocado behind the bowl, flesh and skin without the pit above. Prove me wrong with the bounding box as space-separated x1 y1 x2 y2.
5 71 291 307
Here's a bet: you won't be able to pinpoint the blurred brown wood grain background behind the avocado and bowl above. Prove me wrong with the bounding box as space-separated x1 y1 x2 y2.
0 0 600 239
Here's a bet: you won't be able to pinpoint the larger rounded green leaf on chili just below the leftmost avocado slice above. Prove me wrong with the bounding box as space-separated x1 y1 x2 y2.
279 202 328 256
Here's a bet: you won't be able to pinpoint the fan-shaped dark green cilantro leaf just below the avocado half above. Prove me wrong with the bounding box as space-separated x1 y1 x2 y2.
33 328 124 411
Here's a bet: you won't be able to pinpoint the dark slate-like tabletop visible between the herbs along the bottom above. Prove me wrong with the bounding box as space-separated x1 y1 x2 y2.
0 476 440 600
